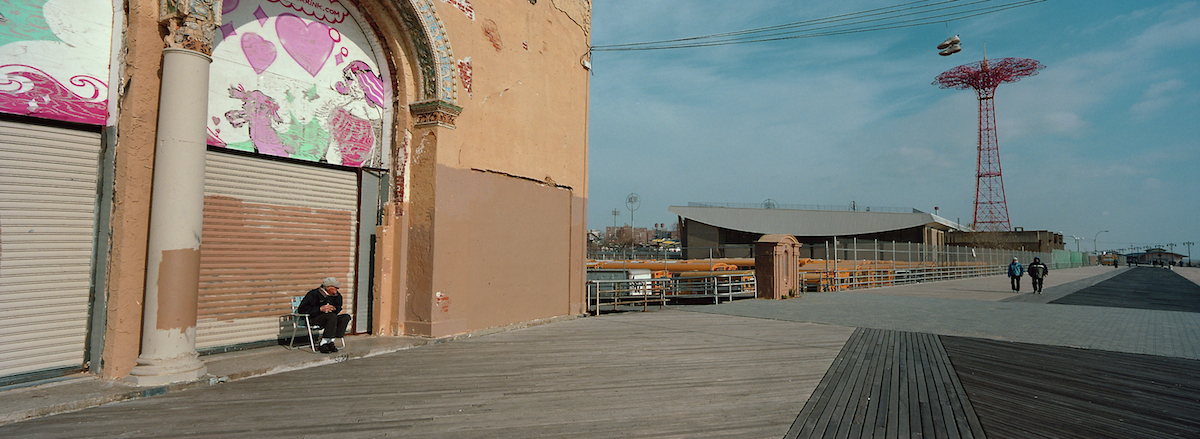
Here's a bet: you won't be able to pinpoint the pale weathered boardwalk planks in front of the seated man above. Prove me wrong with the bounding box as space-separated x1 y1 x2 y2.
0 311 854 438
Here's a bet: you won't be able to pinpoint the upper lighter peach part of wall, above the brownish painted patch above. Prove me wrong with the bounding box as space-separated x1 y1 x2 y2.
434 0 589 190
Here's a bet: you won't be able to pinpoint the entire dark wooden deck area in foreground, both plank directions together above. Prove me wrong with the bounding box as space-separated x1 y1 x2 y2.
786 329 1200 439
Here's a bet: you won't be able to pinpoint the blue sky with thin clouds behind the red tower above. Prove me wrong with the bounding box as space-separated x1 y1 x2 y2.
588 0 1200 255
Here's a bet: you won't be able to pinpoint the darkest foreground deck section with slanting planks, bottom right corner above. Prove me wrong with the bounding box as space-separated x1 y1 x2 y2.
941 335 1200 439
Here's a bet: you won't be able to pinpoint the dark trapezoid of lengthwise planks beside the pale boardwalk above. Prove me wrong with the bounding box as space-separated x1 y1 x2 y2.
785 329 985 439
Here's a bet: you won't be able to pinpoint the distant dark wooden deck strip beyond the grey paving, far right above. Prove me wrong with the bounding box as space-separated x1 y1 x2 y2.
1050 266 1200 313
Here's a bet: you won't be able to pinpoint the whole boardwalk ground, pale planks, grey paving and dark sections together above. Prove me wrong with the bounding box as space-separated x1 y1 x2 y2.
0 267 1200 438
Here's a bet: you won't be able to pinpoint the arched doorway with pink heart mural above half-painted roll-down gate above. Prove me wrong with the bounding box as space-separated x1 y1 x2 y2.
197 0 454 351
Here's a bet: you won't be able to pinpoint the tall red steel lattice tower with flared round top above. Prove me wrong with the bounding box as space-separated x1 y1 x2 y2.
934 58 1045 231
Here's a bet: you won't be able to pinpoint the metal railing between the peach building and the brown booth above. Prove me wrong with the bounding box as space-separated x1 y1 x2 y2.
587 273 756 315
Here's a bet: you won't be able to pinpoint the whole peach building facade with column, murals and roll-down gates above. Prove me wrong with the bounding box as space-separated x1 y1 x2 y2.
0 0 590 385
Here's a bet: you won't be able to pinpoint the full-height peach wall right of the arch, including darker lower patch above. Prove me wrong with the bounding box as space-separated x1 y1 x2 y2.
406 0 589 336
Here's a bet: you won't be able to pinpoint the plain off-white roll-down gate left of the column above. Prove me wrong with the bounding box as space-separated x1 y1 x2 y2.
0 121 101 384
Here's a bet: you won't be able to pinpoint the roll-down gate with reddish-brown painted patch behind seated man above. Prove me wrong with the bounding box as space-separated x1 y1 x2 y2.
196 150 359 351
